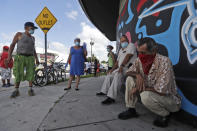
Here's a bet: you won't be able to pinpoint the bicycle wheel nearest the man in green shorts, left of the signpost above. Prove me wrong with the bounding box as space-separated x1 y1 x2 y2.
35 69 47 87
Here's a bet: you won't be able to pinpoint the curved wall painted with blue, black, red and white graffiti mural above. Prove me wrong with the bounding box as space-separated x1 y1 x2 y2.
117 0 197 116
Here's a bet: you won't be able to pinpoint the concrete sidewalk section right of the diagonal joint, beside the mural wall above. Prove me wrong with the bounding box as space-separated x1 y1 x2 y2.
38 77 196 131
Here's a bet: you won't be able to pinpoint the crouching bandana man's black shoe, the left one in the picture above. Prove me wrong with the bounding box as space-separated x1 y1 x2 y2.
118 108 139 120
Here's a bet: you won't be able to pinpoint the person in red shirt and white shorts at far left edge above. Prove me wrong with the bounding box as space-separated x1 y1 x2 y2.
0 46 13 87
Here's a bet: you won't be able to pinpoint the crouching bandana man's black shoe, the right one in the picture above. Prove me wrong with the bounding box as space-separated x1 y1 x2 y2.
153 116 169 128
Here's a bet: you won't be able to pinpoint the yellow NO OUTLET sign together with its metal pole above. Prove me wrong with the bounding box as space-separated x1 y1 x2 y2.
35 7 57 81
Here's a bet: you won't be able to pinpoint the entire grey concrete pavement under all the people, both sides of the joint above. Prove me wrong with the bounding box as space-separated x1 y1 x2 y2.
0 77 196 131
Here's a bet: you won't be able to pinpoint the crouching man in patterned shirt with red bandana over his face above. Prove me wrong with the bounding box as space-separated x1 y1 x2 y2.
118 38 181 127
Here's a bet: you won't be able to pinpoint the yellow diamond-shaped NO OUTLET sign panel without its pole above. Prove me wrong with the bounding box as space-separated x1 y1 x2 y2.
35 7 57 34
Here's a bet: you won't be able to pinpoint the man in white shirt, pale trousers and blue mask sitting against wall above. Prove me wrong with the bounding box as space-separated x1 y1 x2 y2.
97 35 137 104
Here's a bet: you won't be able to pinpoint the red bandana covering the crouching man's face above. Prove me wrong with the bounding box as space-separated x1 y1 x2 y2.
138 54 156 75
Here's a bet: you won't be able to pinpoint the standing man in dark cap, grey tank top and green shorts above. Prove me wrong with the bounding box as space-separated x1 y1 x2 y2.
7 22 39 98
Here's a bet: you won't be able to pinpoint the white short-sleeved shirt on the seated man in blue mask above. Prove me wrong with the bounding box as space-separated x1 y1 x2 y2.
117 43 137 67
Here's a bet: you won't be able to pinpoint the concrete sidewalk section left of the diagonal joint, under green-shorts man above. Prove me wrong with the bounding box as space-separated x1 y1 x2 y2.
0 82 66 131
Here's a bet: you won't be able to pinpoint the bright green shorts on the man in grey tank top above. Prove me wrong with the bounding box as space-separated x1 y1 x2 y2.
13 55 35 83
